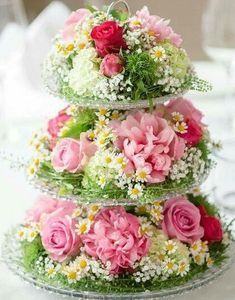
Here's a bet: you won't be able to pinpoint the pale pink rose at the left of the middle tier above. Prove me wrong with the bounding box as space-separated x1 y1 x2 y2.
51 132 96 173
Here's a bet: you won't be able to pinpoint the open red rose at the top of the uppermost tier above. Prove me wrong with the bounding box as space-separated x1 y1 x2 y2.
91 21 127 57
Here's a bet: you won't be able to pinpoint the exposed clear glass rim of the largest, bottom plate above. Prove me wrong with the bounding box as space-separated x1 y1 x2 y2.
2 229 235 300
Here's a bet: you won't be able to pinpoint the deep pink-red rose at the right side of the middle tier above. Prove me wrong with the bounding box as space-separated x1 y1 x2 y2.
179 119 203 146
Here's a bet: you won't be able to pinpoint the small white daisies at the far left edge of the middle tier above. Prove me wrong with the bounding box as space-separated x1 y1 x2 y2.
27 132 50 177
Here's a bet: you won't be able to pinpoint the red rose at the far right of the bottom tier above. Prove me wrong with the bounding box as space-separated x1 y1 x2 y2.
198 205 223 242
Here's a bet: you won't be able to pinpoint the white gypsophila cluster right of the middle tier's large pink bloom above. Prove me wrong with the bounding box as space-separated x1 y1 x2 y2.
169 147 206 182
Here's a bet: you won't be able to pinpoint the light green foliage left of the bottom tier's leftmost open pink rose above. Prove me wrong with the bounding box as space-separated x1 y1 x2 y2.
22 236 45 272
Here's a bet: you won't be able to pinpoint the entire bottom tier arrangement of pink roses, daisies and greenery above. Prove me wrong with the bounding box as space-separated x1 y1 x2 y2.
2 194 233 299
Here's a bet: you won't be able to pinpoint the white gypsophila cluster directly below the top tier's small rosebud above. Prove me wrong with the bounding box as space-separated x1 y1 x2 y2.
93 73 132 102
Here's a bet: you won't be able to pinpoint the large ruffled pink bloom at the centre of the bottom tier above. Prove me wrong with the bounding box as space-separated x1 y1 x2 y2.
82 206 150 274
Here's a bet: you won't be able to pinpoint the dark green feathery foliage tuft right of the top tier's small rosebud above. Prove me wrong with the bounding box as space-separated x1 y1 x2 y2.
125 52 157 100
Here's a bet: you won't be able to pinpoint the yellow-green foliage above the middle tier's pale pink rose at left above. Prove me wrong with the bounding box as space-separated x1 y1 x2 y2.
61 109 96 139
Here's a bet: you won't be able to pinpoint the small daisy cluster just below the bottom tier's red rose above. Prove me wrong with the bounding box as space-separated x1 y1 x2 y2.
190 240 214 267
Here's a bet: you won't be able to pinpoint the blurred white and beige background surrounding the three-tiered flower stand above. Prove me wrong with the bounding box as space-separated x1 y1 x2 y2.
0 0 235 300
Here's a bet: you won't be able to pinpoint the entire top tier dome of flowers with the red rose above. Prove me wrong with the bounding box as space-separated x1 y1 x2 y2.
43 1 210 109
